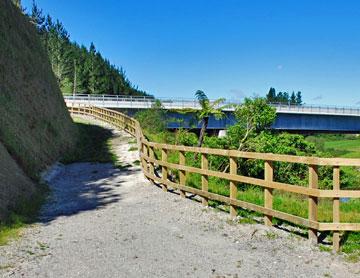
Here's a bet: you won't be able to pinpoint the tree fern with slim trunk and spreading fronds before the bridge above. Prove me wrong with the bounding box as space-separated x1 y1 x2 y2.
195 90 226 147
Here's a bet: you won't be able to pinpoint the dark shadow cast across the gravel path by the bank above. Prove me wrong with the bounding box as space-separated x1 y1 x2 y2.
39 162 139 223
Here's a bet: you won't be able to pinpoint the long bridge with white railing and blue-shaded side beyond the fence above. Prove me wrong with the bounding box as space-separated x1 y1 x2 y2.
64 95 360 133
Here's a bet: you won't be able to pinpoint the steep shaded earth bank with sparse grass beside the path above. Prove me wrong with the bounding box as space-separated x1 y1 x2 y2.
0 0 74 219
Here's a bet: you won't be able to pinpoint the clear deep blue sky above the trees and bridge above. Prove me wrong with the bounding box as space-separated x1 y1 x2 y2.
23 0 360 106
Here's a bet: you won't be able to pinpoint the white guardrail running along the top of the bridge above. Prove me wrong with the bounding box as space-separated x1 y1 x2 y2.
64 95 360 116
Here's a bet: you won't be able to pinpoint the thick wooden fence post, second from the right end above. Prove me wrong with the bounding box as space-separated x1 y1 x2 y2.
309 165 319 243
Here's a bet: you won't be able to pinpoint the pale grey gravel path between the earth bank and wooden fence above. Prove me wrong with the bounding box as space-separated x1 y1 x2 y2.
0 119 360 278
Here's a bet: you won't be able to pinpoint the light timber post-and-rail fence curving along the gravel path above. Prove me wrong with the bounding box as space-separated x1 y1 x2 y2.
69 106 360 251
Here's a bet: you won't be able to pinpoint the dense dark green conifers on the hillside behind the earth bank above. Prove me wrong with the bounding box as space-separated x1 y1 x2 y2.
13 0 148 96
